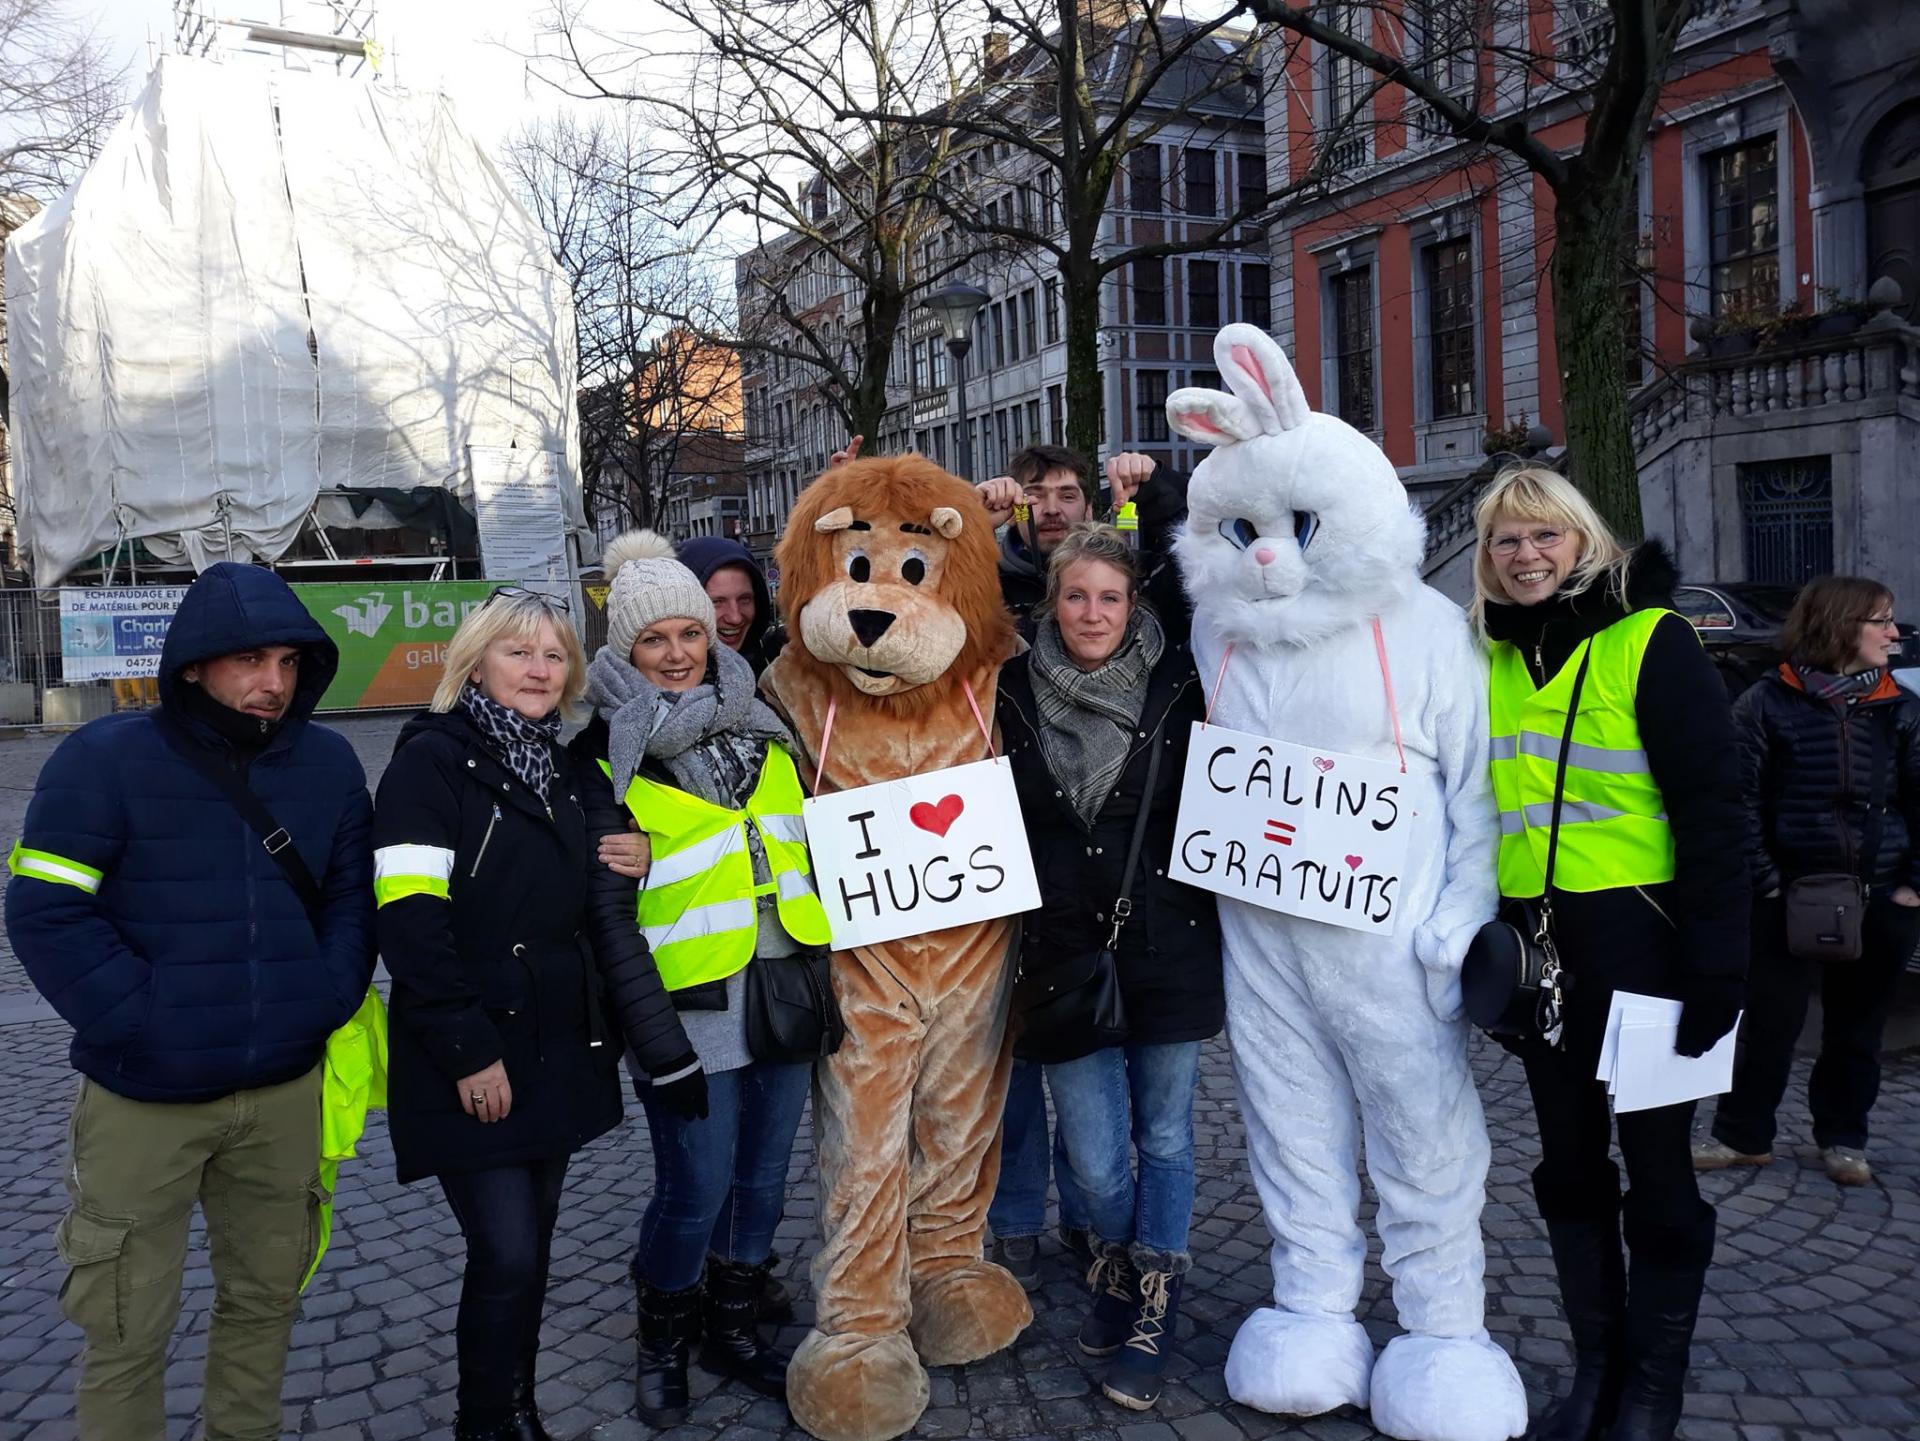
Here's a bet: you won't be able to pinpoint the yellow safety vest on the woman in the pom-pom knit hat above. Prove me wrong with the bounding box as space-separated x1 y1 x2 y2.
601 744 828 990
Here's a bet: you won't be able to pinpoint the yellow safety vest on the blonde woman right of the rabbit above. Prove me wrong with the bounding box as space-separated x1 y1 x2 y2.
1490 610 1674 896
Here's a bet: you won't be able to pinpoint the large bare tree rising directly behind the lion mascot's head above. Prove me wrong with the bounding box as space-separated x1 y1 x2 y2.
537 0 977 436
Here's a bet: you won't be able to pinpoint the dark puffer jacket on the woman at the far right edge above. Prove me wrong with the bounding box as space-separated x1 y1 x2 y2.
1734 666 1920 896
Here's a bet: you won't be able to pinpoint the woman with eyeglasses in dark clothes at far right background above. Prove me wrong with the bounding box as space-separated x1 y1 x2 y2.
1693 576 1920 1186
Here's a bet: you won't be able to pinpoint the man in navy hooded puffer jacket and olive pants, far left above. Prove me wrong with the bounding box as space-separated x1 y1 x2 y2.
6 562 374 1441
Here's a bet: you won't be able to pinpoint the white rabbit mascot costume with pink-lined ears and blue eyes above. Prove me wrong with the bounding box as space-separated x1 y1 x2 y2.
1167 324 1526 1441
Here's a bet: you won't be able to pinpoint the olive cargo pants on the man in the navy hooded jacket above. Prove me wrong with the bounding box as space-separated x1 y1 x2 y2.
58 1067 328 1441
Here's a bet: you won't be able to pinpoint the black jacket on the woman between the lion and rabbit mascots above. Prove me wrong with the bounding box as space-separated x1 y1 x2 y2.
998 641 1225 1046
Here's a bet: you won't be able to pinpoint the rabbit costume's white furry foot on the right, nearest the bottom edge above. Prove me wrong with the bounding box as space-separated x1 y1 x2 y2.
1373 1332 1526 1441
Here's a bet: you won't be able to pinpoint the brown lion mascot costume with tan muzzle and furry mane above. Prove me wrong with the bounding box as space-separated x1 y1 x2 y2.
762 455 1033 1441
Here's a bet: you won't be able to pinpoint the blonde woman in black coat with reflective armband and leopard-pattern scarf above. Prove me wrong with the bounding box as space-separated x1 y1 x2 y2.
374 587 705 1441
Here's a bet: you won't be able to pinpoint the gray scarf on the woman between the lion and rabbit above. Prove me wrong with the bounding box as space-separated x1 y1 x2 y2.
1027 606 1167 825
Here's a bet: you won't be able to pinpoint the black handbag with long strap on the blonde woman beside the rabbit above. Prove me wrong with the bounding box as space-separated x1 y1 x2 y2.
1459 641 1594 1046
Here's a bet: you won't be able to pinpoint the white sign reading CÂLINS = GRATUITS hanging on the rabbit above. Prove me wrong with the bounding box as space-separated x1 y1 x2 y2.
1169 721 1413 934
